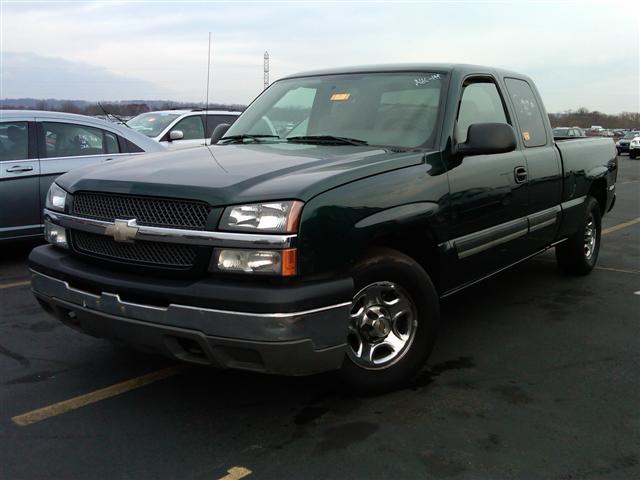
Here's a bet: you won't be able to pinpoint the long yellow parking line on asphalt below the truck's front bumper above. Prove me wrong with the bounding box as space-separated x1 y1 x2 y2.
11 365 182 426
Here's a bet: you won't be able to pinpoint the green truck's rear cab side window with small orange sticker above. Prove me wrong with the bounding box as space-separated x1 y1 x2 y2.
504 78 547 147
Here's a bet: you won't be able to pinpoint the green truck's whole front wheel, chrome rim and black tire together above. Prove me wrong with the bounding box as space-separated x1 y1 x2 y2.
340 249 440 393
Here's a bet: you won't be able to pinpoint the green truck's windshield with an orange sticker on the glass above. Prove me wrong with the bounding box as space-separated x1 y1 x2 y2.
222 72 445 148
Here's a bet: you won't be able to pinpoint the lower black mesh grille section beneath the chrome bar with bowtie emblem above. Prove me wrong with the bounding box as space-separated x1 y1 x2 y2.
71 230 198 269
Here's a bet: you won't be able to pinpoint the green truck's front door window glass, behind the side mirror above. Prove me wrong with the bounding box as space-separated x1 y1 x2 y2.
455 78 509 143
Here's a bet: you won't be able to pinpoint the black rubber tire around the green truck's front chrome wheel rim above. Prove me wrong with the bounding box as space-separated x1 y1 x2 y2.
339 248 440 393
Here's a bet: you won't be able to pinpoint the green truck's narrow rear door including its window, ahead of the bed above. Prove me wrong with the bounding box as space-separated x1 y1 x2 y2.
504 77 564 251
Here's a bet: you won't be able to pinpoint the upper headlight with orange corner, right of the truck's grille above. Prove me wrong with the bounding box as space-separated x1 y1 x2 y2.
219 200 303 233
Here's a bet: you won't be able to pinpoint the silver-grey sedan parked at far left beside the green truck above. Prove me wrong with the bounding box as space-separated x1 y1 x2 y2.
0 110 166 241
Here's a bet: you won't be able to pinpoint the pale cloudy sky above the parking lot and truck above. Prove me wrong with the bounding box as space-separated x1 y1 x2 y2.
0 0 640 113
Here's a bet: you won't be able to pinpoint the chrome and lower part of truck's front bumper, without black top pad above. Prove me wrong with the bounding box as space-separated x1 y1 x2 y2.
31 270 351 375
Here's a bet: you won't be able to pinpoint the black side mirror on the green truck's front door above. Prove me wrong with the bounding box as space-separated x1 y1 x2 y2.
456 123 517 156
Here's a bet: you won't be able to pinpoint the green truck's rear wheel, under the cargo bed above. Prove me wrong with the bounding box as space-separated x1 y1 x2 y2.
556 197 602 275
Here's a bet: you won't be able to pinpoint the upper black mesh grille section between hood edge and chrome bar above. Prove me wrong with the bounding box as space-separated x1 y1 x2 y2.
72 192 209 230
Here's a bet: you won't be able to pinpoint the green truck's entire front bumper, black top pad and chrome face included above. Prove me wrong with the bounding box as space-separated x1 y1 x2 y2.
29 246 353 375
